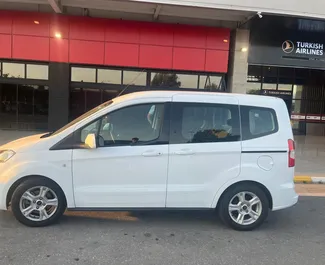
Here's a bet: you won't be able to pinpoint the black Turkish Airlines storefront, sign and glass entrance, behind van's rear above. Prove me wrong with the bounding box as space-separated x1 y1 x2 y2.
247 17 325 136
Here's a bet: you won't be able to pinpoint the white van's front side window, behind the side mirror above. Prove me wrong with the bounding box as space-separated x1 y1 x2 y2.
80 104 164 147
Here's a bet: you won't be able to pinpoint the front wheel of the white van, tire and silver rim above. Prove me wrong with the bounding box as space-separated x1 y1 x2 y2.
11 177 66 227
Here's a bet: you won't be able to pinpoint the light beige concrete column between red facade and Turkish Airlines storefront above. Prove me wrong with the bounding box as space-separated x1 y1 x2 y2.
227 29 249 94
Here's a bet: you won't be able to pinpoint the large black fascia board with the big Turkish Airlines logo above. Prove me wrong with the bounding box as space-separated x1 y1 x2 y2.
248 15 325 69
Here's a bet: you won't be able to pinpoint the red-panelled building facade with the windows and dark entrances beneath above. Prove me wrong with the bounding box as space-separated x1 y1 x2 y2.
0 11 230 130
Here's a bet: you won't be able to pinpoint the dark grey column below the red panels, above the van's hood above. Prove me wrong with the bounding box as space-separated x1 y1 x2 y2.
49 63 70 131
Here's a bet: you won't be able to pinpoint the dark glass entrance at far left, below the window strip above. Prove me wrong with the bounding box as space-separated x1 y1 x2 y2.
0 83 49 131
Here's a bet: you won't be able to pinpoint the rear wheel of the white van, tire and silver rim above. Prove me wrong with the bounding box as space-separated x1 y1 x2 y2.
218 183 269 231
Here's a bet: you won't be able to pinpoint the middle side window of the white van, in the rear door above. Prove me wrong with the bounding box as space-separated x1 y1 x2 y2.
171 103 240 144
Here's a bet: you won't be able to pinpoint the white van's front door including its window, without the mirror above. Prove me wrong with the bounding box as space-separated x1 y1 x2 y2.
73 103 169 208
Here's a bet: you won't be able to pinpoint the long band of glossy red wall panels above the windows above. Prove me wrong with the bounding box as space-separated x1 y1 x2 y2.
0 11 230 72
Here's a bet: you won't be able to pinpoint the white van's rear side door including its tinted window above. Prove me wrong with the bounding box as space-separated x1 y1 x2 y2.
166 95 241 208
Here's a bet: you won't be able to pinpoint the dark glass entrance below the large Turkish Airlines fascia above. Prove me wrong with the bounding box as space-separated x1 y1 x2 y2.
247 65 325 136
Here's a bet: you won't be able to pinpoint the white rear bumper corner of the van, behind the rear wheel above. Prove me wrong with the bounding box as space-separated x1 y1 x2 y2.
272 182 299 211
